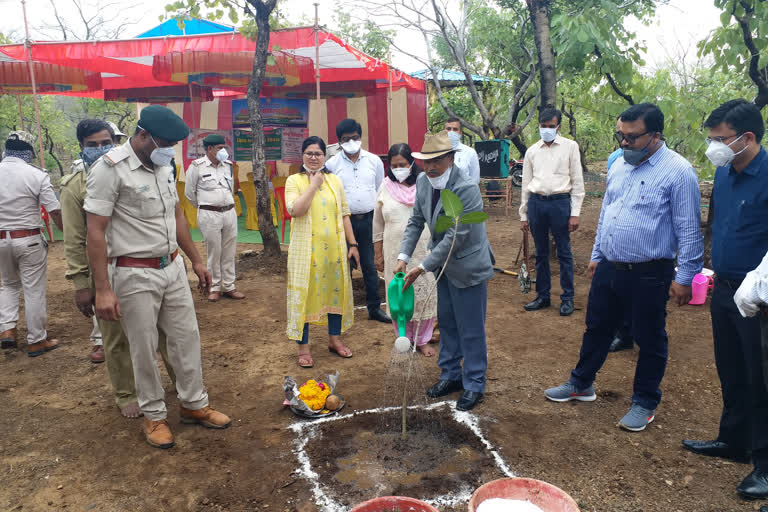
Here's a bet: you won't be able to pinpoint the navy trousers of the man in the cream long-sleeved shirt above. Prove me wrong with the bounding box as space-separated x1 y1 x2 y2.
528 194 573 301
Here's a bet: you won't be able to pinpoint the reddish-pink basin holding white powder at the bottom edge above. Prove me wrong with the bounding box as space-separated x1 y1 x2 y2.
468 478 579 512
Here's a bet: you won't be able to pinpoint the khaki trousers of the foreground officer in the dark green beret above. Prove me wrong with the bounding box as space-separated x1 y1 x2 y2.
109 257 208 421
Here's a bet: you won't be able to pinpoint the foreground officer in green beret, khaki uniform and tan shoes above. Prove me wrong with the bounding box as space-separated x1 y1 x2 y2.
84 105 231 448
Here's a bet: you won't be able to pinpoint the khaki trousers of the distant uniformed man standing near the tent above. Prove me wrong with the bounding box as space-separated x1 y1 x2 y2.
197 208 237 292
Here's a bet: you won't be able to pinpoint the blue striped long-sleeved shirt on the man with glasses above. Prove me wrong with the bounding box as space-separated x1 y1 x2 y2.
592 143 704 286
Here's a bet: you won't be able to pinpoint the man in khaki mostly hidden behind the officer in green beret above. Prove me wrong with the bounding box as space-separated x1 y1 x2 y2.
61 119 176 418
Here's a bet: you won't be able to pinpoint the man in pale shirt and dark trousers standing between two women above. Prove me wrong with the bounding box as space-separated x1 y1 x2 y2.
325 119 392 323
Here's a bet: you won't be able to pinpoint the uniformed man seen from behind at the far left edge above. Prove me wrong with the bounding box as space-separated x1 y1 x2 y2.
0 131 61 357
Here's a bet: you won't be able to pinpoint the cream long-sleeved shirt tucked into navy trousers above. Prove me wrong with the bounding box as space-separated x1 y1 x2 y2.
520 135 584 221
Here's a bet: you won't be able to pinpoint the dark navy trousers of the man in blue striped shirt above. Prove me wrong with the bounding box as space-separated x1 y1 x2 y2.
570 260 675 409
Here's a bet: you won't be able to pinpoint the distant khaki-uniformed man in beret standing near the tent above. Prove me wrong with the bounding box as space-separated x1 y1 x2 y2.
184 134 245 302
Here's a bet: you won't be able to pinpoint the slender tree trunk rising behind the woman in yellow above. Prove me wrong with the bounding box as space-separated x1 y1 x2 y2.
248 2 280 257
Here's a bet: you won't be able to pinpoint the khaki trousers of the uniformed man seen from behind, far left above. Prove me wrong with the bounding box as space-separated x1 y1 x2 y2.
0 234 48 345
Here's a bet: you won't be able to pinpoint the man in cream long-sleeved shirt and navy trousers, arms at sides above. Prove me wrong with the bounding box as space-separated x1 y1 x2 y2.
520 108 584 316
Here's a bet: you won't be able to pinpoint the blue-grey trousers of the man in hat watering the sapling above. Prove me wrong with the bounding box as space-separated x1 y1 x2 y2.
437 279 488 393
